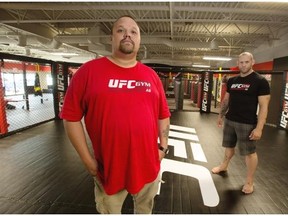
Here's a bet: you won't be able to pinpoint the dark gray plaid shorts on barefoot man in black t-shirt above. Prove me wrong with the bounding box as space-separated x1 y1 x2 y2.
222 119 257 155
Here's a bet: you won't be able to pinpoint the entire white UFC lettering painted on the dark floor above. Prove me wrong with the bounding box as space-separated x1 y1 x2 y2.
158 125 219 207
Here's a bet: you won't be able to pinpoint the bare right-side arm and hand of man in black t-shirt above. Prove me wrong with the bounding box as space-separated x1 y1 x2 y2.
249 95 270 140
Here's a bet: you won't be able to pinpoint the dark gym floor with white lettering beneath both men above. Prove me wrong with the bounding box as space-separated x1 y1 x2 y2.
0 112 288 214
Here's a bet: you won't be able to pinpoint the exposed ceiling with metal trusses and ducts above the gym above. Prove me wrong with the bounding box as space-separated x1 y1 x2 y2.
0 1 288 67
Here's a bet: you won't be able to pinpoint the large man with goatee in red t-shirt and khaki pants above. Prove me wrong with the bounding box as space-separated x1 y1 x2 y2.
60 16 170 214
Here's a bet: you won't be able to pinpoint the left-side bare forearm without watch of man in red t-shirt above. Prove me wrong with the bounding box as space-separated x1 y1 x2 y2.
63 120 97 176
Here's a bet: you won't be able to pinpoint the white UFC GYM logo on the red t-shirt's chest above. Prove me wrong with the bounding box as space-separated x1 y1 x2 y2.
108 79 151 92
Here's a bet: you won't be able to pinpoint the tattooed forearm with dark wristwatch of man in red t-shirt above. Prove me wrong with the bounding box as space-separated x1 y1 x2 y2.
158 118 170 160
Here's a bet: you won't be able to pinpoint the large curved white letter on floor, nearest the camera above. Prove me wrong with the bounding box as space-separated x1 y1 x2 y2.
158 158 219 207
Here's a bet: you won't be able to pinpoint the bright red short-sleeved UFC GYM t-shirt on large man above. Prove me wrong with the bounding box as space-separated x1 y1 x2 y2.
60 57 170 195
